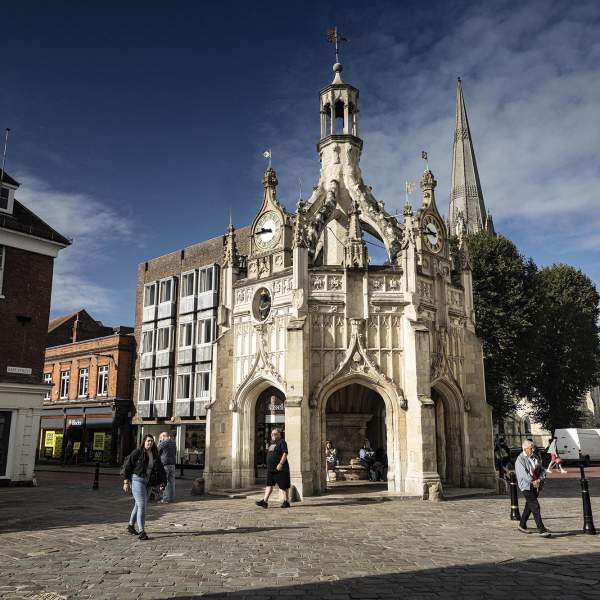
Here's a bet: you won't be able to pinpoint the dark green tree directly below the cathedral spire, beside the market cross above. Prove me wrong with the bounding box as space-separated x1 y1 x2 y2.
467 231 536 423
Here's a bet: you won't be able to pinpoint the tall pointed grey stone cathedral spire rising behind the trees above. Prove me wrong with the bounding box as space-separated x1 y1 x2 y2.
448 77 487 233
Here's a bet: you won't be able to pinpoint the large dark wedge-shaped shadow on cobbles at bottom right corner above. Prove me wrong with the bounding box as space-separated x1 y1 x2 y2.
172 552 600 600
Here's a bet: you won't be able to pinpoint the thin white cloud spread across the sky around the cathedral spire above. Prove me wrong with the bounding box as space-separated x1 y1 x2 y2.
264 0 600 264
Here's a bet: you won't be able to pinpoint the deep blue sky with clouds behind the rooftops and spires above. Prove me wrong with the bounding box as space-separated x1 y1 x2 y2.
0 0 600 324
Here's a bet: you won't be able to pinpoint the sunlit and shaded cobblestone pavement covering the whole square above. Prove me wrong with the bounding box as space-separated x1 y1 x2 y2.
0 469 600 600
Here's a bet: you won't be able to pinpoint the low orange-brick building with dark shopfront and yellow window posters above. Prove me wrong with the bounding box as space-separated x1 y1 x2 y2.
38 310 135 464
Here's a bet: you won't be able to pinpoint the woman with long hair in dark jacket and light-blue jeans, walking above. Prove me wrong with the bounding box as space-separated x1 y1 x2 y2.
121 435 167 540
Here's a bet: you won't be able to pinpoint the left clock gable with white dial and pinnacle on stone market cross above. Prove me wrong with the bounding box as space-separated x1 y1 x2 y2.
248 167 292 279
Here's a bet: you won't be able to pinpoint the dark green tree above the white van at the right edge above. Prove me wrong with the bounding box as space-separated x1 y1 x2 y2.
527 264 600 431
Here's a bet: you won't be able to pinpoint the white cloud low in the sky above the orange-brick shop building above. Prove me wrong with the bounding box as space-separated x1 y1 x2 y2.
16 172 132 317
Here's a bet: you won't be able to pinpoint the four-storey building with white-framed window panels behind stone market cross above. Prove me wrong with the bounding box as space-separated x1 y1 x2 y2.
133 228 249 465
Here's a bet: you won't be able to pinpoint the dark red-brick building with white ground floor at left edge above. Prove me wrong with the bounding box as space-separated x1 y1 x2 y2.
0 172 70 484
